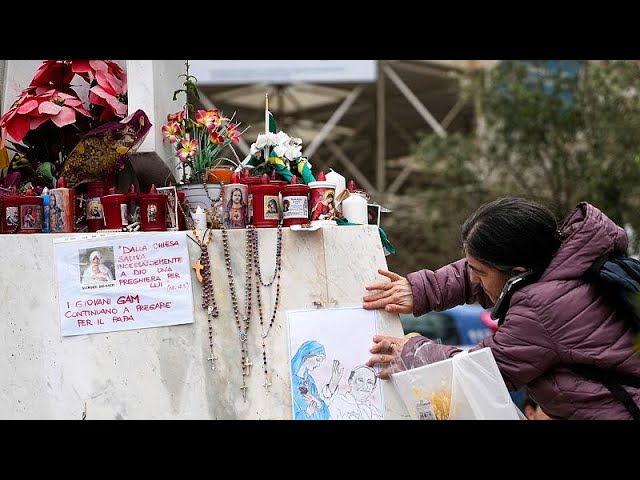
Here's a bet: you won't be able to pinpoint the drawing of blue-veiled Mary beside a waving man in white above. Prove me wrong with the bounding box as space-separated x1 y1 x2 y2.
288 307 384 420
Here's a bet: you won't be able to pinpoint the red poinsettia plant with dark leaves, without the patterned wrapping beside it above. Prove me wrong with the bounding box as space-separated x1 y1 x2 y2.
0 60 127 191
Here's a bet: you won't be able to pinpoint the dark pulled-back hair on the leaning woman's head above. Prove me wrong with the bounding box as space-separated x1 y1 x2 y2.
462 197 560 272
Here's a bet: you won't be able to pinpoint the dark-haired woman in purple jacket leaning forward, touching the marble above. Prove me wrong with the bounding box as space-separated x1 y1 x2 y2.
363 198 640 419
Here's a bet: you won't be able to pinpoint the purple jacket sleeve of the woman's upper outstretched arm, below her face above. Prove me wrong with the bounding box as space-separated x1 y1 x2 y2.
407 258 493 317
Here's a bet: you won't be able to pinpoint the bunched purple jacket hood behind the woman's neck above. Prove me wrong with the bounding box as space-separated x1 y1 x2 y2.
541 202 628 281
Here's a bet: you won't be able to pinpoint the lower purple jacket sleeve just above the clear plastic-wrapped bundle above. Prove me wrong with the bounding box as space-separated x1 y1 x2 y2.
470 292 560 390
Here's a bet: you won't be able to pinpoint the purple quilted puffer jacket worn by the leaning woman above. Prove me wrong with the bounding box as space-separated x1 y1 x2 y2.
402 202 640 420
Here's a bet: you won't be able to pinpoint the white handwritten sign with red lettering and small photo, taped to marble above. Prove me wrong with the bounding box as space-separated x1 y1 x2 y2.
54 232 194 336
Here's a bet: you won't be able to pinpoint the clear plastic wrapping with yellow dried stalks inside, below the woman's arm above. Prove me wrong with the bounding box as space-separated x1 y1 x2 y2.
391 348 525 420
